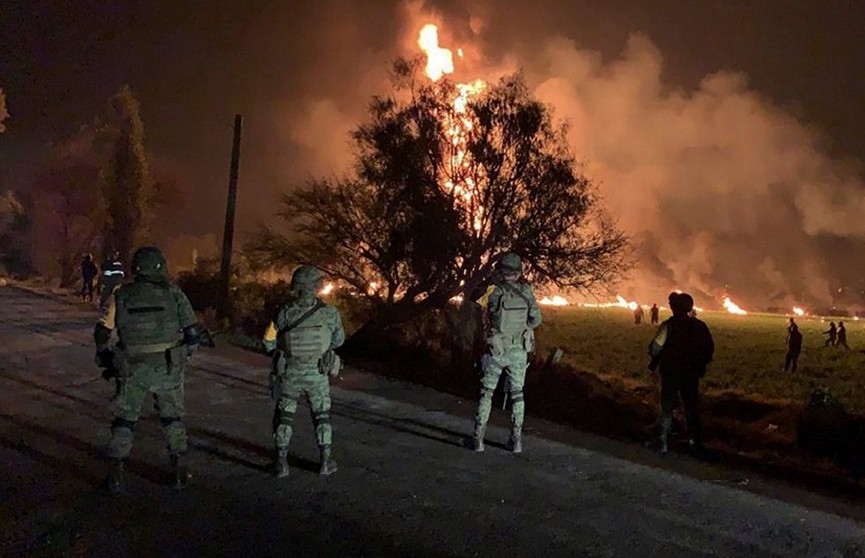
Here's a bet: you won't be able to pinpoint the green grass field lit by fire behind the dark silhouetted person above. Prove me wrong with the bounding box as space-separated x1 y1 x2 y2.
538 307 865 414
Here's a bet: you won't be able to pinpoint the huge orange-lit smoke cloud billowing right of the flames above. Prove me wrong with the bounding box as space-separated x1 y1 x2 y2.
272 3 865 308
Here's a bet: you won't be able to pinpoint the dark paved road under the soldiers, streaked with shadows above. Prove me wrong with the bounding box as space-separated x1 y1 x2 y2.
0 287 865 558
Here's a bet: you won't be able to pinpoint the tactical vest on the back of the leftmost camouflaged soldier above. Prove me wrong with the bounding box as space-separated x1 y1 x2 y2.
114 281 180 355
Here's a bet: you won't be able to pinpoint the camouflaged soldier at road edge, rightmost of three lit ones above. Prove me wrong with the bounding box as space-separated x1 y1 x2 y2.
472 252 541 453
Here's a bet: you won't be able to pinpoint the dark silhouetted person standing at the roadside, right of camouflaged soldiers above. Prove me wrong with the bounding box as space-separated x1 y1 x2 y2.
649 293 715 453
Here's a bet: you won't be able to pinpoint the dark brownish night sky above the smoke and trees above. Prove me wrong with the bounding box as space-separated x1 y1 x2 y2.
0 0 865 306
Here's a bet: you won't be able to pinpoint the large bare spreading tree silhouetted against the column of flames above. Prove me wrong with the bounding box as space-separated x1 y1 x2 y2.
254 60 627 321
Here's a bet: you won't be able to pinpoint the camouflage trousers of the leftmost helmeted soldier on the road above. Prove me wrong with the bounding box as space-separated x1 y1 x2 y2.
108 355 186 459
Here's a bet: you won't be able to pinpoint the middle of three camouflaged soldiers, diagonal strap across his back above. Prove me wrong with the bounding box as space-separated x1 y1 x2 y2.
263 266 345 477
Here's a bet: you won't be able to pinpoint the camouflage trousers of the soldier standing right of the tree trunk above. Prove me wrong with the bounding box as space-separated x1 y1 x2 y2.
475 345 528 436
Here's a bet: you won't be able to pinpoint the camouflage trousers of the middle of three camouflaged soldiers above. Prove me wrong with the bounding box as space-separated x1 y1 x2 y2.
273 364 333 449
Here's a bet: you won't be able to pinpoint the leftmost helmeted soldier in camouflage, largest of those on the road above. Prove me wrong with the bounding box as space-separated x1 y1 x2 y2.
93 247 203 492
